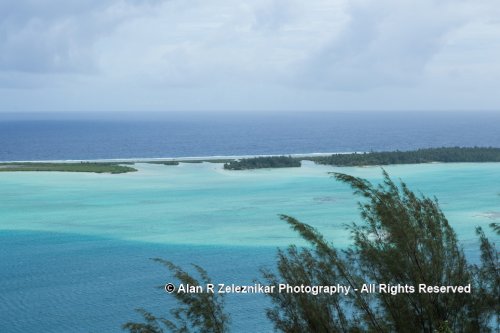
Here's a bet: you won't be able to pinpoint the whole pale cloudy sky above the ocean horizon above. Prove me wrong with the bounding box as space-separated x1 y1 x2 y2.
0 0 500 113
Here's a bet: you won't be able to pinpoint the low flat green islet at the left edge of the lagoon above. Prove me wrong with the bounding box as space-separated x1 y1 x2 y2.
0 162 137 174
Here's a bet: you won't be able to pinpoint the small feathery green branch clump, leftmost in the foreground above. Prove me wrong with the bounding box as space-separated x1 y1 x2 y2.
123 259 229 333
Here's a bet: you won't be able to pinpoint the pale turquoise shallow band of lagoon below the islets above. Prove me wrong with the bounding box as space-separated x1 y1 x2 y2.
0 162 500 246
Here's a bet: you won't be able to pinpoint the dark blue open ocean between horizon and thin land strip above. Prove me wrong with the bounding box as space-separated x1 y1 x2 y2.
0 112 500 161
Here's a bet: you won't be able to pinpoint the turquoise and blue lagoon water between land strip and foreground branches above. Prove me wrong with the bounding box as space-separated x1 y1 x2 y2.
0 162 500 332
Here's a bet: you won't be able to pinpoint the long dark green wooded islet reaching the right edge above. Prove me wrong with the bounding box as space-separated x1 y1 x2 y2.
304 147 500 166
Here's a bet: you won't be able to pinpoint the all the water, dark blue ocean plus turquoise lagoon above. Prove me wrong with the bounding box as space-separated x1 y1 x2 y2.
0 112 500 333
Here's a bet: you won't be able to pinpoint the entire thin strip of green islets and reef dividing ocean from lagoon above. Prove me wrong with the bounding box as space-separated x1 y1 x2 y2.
0 147 500 174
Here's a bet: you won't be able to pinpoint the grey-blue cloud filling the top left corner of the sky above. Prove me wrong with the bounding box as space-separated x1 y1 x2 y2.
0 0 166 73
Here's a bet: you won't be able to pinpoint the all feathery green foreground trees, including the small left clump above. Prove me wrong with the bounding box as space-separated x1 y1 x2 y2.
123 171 500 333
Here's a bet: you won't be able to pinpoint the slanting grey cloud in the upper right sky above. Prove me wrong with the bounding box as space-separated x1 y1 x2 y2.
298 0 465 90
